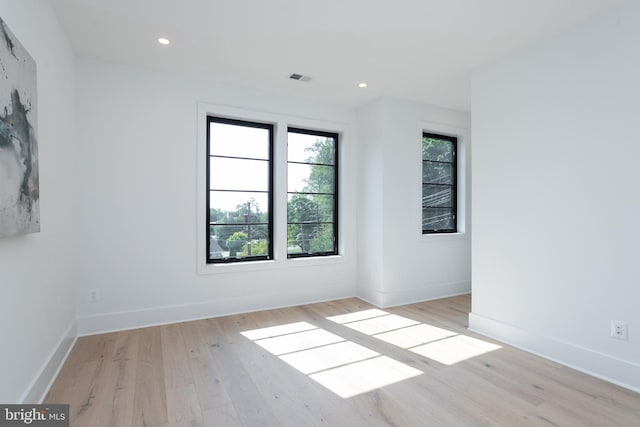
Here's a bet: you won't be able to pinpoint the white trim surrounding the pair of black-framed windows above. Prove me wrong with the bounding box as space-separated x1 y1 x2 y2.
198 101 352 274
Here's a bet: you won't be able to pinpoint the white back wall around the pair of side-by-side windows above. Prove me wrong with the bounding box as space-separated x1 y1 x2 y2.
75 60 357 334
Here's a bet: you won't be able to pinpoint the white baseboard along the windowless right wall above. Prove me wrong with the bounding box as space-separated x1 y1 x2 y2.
469 313 640 393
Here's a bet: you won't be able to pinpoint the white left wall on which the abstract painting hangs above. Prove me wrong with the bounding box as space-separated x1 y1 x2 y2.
0 0 75 403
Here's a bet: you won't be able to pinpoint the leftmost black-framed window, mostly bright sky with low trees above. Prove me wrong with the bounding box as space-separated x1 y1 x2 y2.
206 116 274 263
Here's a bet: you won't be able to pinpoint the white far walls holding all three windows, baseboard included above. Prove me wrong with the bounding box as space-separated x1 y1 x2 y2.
75 60 470 334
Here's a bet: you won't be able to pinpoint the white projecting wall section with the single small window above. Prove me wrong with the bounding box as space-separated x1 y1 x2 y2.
358 98 471 307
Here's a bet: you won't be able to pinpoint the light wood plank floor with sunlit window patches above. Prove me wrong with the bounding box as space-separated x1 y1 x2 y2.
46 295 640 427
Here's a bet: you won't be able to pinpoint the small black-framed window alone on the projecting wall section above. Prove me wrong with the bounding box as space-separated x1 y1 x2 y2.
422 132 458 234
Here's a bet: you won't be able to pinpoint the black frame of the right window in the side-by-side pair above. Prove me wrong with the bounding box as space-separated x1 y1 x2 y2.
285 126 340 259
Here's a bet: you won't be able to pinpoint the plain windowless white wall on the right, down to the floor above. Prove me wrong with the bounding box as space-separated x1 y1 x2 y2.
471 2 640 389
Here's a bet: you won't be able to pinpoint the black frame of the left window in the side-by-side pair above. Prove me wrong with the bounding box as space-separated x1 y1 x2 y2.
205 114 276 264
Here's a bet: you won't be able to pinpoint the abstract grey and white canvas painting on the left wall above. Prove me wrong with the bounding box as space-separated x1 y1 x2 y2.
0 19 40 237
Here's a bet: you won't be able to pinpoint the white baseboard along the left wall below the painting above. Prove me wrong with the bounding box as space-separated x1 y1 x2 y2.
20 320 78 403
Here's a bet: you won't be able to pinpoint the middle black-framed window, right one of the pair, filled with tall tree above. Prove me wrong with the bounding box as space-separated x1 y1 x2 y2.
287 127 338 258
